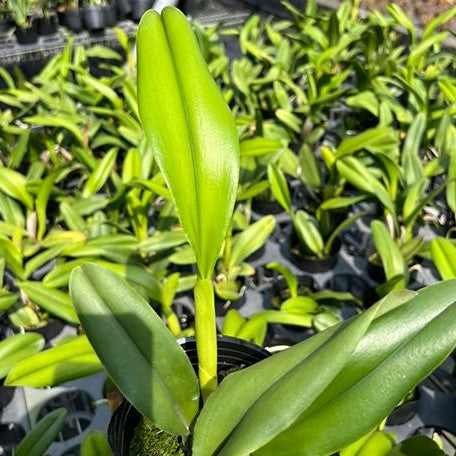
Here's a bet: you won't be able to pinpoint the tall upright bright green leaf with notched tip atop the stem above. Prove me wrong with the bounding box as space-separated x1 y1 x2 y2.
138 7 239 278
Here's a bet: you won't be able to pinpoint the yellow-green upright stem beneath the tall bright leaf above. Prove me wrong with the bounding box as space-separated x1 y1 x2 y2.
194 277 217 400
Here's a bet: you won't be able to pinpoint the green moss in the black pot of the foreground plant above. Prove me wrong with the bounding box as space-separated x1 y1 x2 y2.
129 418 185 456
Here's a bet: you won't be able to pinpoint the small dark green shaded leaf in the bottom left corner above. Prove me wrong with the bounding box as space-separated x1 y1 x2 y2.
14 408 68 456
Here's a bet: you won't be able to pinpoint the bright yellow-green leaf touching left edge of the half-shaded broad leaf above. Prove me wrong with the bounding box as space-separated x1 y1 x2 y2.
5 336 103 388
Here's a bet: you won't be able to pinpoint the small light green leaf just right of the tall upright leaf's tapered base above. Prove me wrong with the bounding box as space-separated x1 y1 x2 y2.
228 215 276 269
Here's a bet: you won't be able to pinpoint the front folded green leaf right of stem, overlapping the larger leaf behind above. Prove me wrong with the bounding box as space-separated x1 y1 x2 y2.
193 302 376 456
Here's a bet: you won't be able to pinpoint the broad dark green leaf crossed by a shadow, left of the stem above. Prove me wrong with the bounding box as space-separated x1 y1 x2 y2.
70 264 199 434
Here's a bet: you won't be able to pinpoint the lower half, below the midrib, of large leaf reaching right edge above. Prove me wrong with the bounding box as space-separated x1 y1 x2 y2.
258 282 456 456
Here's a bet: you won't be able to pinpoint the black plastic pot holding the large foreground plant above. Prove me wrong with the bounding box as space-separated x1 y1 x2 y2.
108 336 270 456
